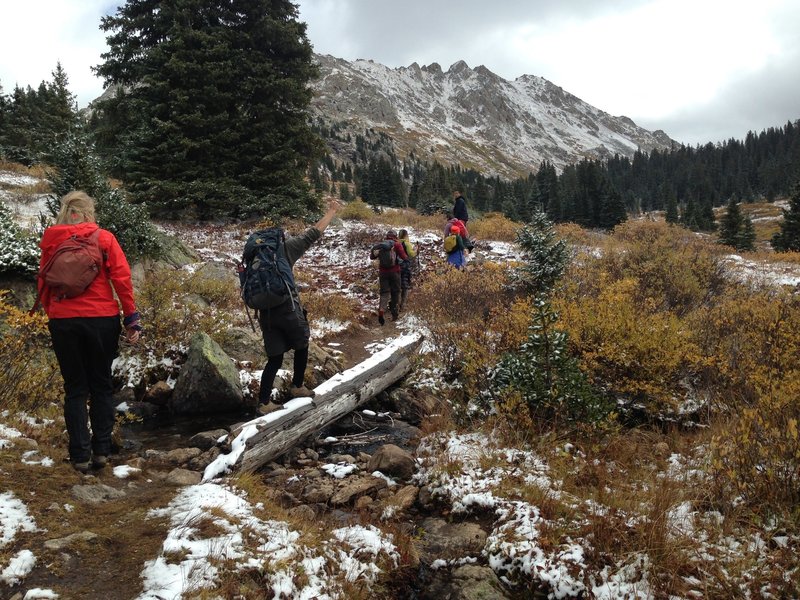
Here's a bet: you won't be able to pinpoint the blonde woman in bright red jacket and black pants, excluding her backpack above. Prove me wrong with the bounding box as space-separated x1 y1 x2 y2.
38 191 142 473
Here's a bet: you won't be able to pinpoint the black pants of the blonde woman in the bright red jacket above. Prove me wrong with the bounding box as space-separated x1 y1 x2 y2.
48 316 122 462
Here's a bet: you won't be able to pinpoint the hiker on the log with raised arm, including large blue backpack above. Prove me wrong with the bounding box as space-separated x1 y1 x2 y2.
239 201 339 413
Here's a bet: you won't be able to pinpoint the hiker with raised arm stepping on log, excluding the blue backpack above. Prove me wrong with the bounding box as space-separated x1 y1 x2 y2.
258 201 339 412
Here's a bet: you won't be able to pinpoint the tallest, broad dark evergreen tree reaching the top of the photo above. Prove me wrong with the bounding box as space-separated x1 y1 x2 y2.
96 0 320 218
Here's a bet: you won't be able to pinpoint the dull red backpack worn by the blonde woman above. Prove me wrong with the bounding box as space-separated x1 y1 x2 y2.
31 228 105 312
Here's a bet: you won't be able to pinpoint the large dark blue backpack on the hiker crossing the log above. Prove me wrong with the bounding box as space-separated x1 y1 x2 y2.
239 227 297 310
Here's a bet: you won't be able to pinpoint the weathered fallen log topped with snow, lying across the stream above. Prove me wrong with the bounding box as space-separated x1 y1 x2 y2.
203 334 422 481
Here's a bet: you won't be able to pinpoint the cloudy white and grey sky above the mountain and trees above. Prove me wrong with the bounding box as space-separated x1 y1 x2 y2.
0 0 800 145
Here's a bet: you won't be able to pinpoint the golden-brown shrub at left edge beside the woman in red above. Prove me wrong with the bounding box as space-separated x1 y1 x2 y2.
0 292 63 414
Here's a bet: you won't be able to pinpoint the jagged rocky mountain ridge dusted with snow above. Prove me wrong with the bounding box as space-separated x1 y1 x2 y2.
312 55 675 177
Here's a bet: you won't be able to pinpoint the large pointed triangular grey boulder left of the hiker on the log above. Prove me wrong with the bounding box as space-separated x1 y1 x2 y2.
168 332 245 414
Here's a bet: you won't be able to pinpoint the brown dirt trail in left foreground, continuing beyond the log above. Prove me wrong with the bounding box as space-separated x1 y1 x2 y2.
0 318 412 600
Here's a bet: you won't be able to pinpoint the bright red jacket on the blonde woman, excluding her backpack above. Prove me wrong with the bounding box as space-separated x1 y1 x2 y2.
38 223 136 319
